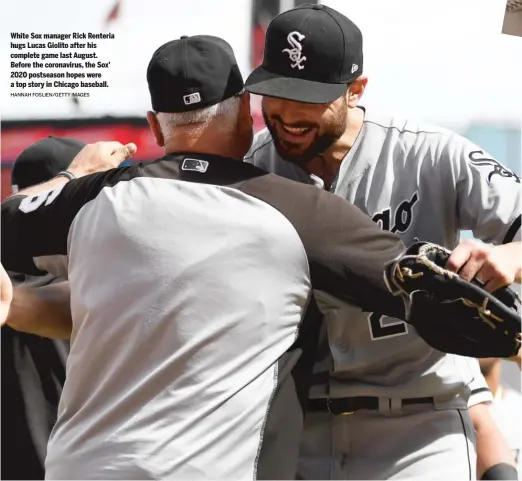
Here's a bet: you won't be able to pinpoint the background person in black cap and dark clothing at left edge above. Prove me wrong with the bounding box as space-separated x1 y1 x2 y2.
1 137 85 479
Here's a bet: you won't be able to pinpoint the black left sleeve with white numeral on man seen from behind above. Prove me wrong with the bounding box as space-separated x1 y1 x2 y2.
1 167 132 275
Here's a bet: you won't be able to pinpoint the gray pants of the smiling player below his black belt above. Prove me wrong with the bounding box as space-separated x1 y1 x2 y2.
297 406 477 480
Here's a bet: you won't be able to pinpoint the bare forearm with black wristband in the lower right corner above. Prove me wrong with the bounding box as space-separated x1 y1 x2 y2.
469 403 517 479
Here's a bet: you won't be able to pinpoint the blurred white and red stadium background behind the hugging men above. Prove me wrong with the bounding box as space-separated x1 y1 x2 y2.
0 0 522 389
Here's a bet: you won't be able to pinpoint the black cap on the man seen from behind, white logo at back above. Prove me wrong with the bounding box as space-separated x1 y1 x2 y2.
147 35 244 112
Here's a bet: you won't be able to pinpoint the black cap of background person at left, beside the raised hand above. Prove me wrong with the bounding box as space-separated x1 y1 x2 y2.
11 136 86 192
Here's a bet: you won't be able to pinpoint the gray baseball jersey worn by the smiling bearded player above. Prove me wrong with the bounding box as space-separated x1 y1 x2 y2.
245 108 521 408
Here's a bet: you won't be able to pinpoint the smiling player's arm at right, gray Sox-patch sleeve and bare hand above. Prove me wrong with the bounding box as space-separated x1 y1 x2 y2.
437 135 522 292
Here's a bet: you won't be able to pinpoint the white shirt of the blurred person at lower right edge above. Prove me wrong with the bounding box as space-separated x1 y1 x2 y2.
491 387 522 479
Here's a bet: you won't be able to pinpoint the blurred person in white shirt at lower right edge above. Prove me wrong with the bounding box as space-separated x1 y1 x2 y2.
479 358 522 478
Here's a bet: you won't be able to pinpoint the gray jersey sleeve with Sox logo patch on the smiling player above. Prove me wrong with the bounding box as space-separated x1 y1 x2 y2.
440 134 522 245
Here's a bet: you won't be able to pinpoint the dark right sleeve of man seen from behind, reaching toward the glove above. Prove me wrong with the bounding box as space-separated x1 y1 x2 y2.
241 174 405 319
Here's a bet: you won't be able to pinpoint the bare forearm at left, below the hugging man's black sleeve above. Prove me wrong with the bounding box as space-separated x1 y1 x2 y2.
5 281 72 339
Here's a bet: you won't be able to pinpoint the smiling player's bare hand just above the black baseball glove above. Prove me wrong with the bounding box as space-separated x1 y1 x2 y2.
446 239 522 292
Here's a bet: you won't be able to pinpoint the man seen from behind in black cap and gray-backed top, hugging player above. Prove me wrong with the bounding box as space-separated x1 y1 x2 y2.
1 36 426 479
